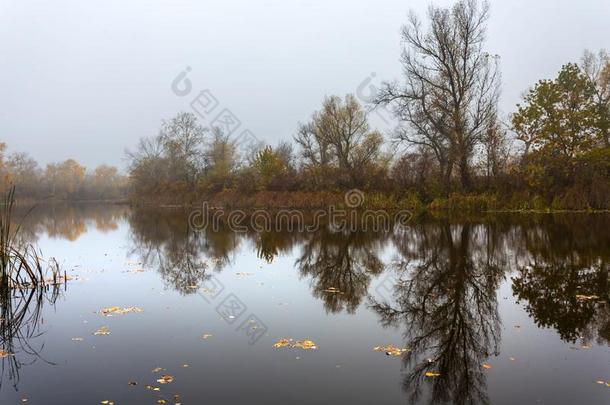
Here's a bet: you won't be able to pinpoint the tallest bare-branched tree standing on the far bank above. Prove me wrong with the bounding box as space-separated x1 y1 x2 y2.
375 0 500 191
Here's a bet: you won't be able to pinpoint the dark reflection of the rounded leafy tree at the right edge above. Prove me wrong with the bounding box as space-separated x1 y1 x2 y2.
512 216 610 345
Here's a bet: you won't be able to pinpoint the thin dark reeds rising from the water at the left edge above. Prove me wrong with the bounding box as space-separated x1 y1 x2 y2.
0 187 65 293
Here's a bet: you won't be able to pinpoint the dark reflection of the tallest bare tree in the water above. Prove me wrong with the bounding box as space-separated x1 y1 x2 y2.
371 223 505 404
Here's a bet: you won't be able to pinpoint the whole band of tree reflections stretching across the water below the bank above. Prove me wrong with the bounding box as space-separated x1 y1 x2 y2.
13 207 610 404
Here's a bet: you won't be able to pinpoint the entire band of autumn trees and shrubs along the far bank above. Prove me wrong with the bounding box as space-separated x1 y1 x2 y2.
0 0 610 213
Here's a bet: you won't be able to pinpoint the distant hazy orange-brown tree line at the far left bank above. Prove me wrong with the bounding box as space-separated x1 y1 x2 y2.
0 143 129 201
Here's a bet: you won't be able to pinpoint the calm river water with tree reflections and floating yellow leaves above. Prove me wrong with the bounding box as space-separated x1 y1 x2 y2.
0 205 610 405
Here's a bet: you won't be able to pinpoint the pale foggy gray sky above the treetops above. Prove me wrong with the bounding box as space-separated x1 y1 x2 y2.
0 0 610 167
